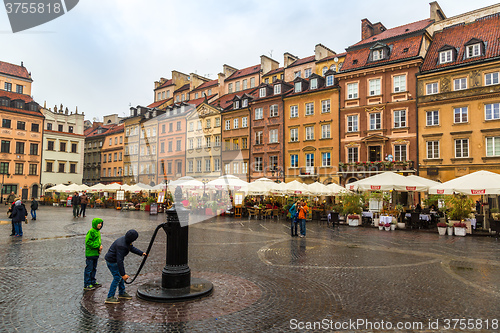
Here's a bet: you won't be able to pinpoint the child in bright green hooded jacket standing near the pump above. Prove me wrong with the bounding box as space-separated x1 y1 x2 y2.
83 217 104 290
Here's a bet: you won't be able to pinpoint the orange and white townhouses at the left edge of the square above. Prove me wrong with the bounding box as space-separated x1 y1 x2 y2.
0 61 84 201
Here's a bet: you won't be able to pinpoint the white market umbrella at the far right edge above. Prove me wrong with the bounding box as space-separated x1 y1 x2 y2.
429 170 500 195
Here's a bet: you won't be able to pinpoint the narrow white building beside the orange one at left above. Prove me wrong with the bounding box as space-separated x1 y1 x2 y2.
41 105 85 190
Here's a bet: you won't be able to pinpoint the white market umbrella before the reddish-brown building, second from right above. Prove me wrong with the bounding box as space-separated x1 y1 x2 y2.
346 171 429 192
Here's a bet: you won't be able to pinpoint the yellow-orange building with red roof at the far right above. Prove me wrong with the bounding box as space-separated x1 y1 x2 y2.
418 15 500 182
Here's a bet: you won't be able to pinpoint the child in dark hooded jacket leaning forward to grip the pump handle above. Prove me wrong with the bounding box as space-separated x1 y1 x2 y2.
104 229 146 304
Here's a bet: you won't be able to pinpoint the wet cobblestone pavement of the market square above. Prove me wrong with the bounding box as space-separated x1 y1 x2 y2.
0 206 500 332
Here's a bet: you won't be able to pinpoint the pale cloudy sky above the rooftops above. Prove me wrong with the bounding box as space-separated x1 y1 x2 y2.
0 0 493 120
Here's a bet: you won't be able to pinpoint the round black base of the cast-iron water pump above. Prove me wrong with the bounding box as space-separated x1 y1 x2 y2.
137 278 214 303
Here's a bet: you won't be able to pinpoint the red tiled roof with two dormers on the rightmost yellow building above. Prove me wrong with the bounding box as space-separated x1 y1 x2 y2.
422 14 500 72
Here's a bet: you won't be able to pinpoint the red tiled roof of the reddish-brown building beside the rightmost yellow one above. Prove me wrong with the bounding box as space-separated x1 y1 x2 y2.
341 36 422 72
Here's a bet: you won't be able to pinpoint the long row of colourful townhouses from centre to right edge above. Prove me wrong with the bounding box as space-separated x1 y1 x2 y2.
85 2 500 184
